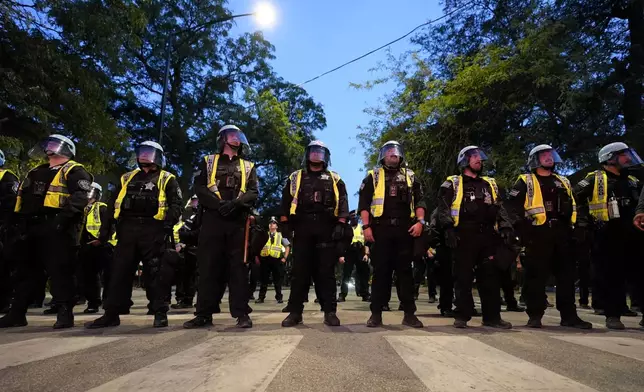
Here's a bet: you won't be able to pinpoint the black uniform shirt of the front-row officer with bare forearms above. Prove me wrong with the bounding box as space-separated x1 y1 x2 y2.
358 169 427 218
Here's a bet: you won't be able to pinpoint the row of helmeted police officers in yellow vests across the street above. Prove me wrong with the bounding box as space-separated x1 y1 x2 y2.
0 125 644 329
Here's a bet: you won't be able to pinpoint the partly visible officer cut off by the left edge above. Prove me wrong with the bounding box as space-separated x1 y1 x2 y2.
0 150 19 313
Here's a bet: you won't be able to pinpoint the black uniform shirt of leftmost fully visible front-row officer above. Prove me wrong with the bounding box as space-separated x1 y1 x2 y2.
20 164 93 226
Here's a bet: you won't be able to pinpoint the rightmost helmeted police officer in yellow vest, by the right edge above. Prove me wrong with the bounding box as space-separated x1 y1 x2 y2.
572 142 643 329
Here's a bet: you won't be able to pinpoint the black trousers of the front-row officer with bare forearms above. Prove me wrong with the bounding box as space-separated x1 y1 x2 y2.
371 219 416 313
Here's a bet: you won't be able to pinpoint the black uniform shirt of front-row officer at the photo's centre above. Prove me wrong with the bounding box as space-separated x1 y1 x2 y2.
282 170 349 222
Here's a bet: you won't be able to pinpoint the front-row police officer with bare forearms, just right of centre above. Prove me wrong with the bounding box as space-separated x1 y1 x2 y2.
358 141 425 328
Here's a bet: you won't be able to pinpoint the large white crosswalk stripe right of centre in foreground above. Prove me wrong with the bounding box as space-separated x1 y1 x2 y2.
385 336 595 392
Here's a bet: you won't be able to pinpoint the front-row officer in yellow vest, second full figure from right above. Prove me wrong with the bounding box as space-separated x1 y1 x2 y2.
507 144 592 329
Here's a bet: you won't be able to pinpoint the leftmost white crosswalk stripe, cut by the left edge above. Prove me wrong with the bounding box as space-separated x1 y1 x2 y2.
0 336 122 369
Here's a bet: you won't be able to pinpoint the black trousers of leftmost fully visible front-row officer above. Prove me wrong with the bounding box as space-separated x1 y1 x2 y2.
11 215 77 315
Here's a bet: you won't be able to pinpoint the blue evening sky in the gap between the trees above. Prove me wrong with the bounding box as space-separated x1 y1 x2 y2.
229 0 442 209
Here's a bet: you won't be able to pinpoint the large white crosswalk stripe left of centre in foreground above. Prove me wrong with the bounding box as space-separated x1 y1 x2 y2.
86 335 302 392
